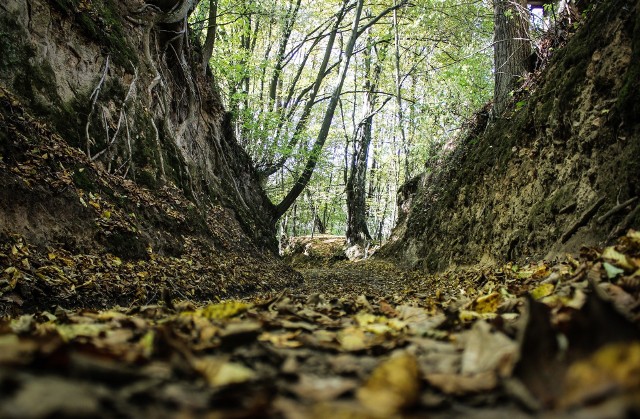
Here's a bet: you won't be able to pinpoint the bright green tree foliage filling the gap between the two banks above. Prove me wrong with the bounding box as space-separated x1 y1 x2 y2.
191 0 493 240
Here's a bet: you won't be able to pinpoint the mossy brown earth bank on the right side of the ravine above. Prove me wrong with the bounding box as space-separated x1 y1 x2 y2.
381 0 640 270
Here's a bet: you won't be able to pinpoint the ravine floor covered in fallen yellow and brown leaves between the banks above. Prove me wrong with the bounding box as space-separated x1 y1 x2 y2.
0 231 640 419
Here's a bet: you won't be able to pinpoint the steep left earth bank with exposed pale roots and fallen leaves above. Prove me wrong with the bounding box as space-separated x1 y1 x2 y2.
0 0 299 314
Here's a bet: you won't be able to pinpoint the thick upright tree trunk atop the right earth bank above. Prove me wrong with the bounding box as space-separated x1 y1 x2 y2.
493 0 531 116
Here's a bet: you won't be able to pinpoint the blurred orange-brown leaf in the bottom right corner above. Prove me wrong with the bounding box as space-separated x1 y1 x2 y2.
560 341 640 407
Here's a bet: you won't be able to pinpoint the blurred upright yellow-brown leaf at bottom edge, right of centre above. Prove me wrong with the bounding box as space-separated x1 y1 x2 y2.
356 351 420 417
